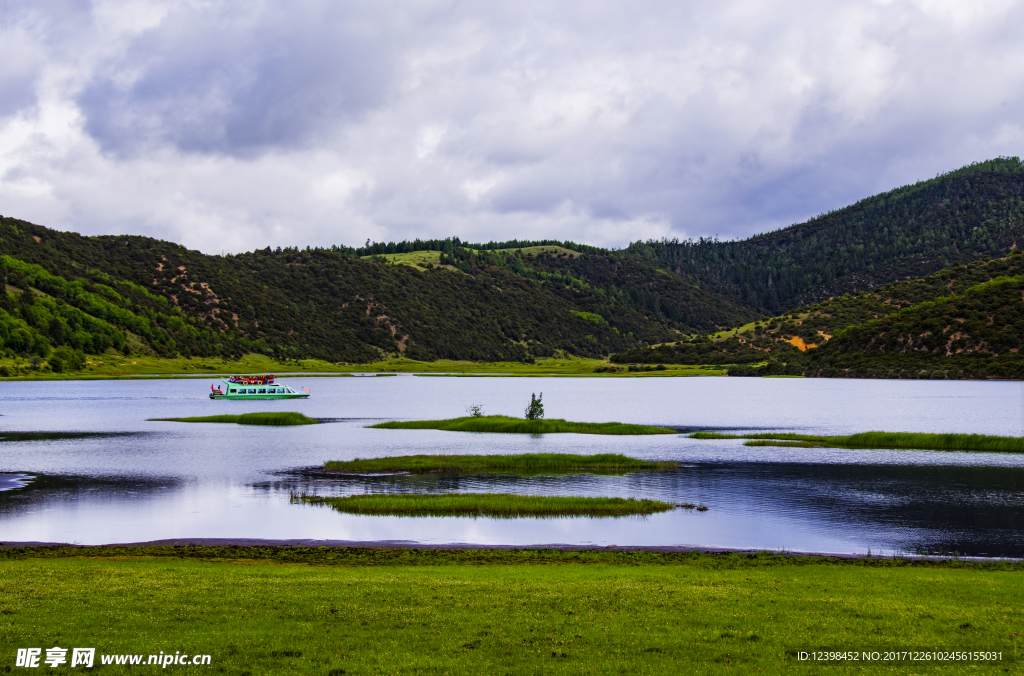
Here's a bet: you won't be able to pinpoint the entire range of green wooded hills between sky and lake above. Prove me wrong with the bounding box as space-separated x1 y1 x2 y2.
6 158 1024 377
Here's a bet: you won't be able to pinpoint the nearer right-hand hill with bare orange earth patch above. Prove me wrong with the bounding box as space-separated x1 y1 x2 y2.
611 251 1024 378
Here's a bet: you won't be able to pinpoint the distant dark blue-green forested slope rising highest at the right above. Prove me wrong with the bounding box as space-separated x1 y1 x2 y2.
628 158 1024 314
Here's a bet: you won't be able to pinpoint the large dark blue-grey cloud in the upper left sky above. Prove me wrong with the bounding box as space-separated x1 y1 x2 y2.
77 2 395 155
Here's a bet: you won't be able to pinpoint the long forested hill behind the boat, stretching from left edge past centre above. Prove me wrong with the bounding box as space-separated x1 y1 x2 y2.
0 218 753 362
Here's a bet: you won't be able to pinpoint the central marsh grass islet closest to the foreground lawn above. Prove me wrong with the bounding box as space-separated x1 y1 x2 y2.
291 493 675 518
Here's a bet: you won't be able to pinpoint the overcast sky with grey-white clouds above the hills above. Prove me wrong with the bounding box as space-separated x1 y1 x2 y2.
0 0 1024 253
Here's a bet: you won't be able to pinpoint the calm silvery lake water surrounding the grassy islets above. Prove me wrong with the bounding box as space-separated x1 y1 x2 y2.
0 375 1024 556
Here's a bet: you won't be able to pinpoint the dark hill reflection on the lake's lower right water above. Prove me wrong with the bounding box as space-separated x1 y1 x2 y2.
262 463 1024 557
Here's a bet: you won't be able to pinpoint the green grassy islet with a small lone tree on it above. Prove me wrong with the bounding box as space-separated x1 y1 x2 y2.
368 416 677 434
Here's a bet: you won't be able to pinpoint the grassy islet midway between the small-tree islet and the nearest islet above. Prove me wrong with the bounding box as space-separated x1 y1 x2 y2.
324 453 679 474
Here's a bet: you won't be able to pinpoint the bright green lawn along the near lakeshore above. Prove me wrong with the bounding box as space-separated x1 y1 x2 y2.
0 547 1024 676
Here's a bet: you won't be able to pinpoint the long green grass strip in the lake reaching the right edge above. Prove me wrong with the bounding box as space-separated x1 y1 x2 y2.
690 432 1024 453
